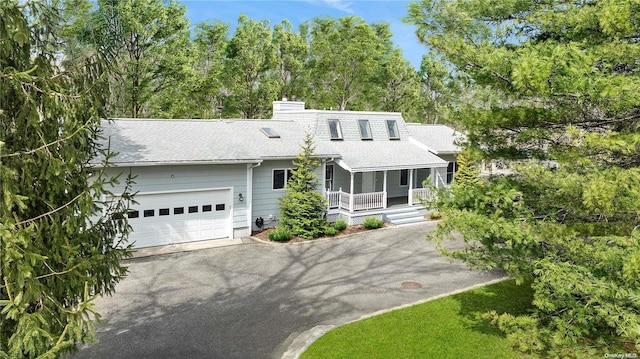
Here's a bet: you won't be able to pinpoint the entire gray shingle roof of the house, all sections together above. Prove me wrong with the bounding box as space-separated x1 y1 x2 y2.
97 110 458 171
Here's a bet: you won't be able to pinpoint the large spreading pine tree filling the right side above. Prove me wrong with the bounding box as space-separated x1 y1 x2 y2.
408 0 640 357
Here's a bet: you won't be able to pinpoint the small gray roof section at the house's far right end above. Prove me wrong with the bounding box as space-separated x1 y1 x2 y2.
407 123 464 154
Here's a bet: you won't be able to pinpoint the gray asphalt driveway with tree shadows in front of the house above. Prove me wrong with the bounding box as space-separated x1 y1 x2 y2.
74 223 501 359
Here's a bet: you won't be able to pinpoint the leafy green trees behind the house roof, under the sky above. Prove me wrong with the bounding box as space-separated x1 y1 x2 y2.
62 0 462 123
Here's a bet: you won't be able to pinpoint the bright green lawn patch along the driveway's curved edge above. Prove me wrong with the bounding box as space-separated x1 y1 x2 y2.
301 280 532 359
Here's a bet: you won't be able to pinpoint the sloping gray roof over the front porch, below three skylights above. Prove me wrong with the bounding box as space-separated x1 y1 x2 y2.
331 141 447 172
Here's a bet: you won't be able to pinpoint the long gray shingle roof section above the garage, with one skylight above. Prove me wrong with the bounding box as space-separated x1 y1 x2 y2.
97 119 337 165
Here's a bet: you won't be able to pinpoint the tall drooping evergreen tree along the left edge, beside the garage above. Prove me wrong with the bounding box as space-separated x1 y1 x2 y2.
0 0 129 358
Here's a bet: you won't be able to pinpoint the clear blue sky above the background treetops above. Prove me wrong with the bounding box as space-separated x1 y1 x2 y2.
181 0 426 69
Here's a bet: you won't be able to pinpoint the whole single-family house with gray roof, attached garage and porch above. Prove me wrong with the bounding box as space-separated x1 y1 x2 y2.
102 99 457 248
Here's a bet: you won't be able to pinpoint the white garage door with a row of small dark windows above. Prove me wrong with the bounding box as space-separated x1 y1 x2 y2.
128 189 232 248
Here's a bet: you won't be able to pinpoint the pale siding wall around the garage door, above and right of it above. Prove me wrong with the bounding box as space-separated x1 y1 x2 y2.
108 164 250 236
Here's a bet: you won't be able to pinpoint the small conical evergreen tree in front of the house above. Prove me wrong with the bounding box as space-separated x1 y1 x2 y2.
280 132 327 239
